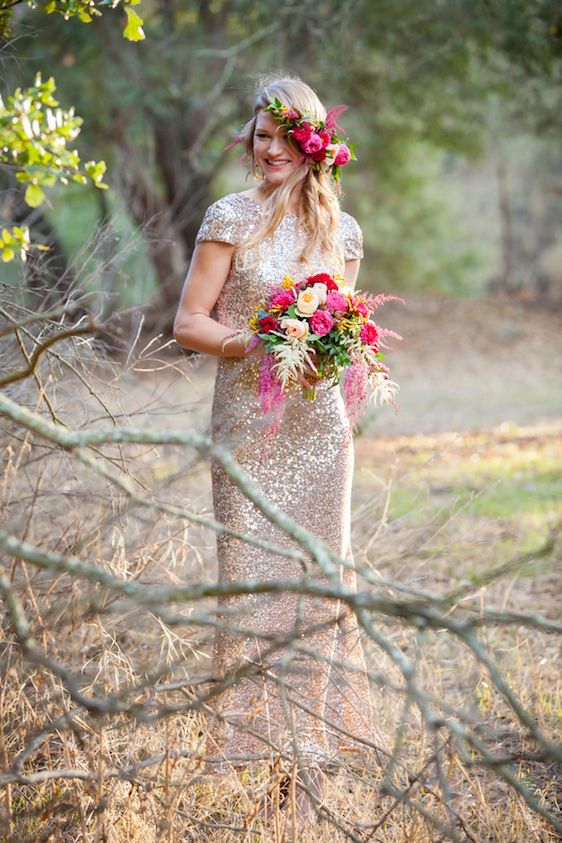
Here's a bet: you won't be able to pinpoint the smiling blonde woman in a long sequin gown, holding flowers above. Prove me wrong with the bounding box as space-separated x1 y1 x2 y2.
174 72 374 792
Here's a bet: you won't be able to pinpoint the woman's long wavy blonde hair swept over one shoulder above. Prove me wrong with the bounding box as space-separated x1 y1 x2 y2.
234 74 340 270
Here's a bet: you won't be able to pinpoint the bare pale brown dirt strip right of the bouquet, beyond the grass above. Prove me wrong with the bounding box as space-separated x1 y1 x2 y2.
369 296 562 435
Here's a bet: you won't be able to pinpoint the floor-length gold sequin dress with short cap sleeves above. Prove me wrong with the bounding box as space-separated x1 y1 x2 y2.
196 193 374 769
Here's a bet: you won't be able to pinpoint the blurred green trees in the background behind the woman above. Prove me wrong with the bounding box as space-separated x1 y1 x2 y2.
1 0 561 330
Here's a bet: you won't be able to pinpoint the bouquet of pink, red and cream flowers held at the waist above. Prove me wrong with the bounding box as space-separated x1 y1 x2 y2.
246 273 402 427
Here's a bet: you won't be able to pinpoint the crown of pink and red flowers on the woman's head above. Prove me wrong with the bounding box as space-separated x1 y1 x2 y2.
263 98 357 184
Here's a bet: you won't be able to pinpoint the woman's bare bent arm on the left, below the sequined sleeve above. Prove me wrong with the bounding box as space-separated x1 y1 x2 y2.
174 240 245 357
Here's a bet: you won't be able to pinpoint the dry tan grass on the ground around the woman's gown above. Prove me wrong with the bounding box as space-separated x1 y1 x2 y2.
0 298 562 843
